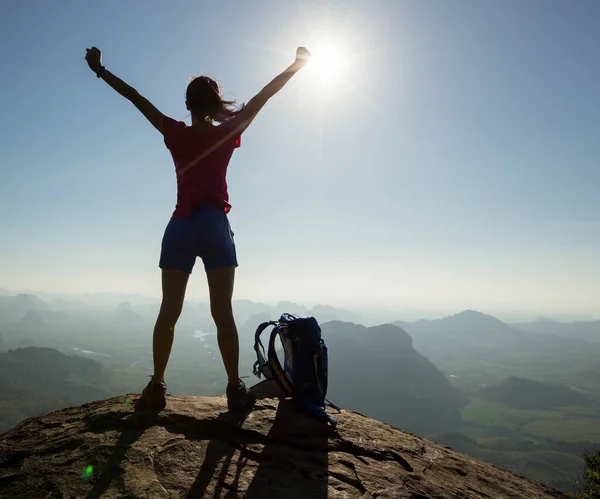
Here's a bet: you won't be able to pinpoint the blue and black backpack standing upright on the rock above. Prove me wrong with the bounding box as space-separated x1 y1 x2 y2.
253 314 340 426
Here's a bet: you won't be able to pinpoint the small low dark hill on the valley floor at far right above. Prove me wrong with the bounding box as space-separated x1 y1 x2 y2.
479 376 590 410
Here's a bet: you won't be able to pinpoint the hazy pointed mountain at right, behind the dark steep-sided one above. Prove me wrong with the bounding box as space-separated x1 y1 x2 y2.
394 310 600 399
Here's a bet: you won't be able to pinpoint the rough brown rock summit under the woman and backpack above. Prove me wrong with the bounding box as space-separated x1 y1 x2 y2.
0 395 566 499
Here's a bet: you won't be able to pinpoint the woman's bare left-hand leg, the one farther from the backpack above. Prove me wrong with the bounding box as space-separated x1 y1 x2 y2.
152 269 190 381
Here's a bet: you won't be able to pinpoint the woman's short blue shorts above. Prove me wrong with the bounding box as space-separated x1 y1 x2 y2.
159 203 238 274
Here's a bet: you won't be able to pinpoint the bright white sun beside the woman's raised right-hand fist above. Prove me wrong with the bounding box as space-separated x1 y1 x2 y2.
306 40 352 90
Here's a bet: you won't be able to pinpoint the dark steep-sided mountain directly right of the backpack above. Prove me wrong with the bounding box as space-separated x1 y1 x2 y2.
322 321 467 435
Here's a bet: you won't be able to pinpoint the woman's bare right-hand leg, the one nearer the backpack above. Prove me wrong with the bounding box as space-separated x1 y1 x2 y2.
206 267 240 385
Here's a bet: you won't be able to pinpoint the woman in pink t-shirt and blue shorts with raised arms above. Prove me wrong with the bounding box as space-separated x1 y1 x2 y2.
85 47 310 411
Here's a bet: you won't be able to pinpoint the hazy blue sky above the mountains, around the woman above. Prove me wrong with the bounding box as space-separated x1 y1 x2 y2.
0 0 600 313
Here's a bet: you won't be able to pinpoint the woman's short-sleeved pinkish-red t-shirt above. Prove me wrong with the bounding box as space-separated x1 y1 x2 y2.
163 116 241 218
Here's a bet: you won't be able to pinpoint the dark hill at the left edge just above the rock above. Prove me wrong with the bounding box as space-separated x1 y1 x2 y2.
0 347 113 432
